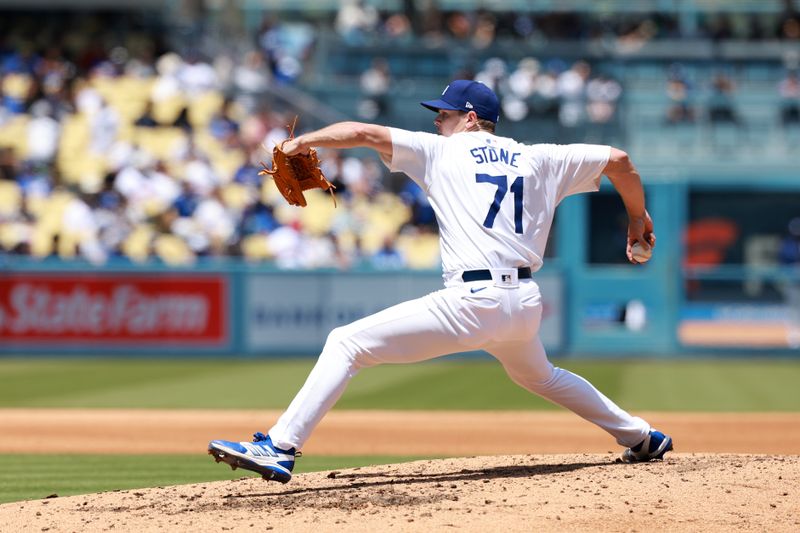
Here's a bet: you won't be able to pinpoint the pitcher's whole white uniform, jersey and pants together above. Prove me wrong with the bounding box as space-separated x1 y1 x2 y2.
269 129 650 456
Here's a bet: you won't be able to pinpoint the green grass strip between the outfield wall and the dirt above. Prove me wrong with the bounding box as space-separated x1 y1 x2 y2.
0 359 800 411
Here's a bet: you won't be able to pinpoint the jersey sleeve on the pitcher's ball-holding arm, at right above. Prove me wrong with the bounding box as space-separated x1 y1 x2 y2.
547 144 611 201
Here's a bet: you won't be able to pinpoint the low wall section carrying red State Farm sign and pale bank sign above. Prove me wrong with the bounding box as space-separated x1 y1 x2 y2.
0 265 565 356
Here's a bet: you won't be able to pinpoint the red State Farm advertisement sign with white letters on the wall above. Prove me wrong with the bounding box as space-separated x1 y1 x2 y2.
0 273 228 346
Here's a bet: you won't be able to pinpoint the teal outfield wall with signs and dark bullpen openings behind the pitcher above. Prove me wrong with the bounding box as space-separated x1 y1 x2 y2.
0 179 800 357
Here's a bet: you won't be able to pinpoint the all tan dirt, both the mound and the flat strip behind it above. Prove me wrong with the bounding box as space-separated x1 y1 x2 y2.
0 410 800 533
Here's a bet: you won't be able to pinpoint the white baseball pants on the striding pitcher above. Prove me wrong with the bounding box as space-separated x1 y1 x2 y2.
269 280 650 450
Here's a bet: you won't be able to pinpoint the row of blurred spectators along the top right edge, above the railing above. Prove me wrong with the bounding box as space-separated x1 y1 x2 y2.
336 0 800 48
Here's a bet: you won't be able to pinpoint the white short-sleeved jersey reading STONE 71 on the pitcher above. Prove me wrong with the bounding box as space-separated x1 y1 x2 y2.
390 128 611 280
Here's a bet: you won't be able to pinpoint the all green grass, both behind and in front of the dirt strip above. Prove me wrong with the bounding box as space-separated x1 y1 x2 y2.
0 358 800 502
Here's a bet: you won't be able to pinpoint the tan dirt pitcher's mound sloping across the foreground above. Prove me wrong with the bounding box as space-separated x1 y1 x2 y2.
0 453 800 533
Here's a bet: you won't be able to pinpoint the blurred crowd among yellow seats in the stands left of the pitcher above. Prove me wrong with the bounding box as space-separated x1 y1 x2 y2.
0 11 438 268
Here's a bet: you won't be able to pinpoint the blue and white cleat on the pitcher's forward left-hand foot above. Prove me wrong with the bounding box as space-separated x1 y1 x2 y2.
208 433 300 483
